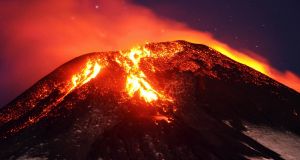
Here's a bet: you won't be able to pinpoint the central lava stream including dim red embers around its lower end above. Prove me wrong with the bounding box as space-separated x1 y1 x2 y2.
115 47 178 124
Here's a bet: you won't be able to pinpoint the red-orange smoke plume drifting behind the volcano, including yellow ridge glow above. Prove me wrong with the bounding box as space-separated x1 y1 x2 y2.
0 0 300 105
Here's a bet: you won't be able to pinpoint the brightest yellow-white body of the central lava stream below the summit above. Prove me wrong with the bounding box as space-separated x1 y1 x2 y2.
116 47 172 103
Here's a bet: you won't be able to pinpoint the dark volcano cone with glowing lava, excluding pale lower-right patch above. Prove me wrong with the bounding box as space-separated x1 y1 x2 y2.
0 41 300 160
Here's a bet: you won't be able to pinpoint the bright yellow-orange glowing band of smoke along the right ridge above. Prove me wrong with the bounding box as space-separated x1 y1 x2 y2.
158 31 300 92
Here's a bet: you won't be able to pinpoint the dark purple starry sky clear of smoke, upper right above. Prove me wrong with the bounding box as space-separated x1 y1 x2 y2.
135 0 300 75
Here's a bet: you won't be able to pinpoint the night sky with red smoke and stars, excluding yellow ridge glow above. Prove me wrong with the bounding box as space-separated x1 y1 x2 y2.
0 0 300 107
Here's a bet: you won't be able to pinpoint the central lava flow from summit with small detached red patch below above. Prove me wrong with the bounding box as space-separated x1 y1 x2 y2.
115 46 179 123
